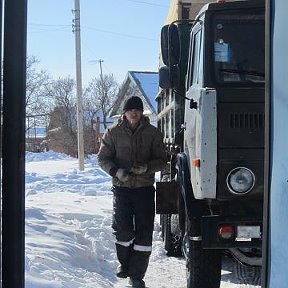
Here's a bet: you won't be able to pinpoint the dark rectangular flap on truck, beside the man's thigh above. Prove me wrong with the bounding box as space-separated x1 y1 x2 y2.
156 181 178 214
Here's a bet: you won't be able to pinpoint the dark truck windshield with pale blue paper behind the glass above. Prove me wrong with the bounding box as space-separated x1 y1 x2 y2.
212 9 265 86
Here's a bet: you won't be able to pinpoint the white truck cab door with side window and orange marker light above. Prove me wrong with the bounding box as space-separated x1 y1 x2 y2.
184 22 217 199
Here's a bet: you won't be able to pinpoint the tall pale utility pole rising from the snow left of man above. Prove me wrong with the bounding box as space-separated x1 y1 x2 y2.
73 0 84 171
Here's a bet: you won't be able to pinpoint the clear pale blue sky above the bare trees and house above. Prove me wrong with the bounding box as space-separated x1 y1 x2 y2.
27 0 170 86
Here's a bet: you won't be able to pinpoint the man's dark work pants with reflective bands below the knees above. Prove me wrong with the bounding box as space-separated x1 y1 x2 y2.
112 186 155 279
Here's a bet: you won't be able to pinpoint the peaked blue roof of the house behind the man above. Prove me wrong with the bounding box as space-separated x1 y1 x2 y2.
109 71 158 117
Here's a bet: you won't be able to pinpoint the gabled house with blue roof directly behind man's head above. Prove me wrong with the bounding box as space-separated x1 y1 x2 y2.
109 71 158 126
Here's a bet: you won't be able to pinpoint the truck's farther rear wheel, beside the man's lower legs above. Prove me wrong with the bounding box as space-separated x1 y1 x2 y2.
162 214 182 256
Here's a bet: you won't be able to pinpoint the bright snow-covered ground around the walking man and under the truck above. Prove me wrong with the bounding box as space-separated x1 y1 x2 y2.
25 151 261 288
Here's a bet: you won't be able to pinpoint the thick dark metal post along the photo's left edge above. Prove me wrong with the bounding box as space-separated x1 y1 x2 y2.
2 0 27 288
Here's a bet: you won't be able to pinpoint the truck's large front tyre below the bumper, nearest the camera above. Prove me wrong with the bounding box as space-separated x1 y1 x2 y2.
183 218 221 288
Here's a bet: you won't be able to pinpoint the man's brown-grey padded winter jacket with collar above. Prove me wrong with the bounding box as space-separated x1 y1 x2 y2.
98 116 167 188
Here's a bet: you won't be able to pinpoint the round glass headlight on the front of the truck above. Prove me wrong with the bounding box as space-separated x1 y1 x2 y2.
226 167 255 194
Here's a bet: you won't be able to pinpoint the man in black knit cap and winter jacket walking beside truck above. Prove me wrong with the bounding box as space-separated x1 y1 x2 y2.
98 96 167 288
